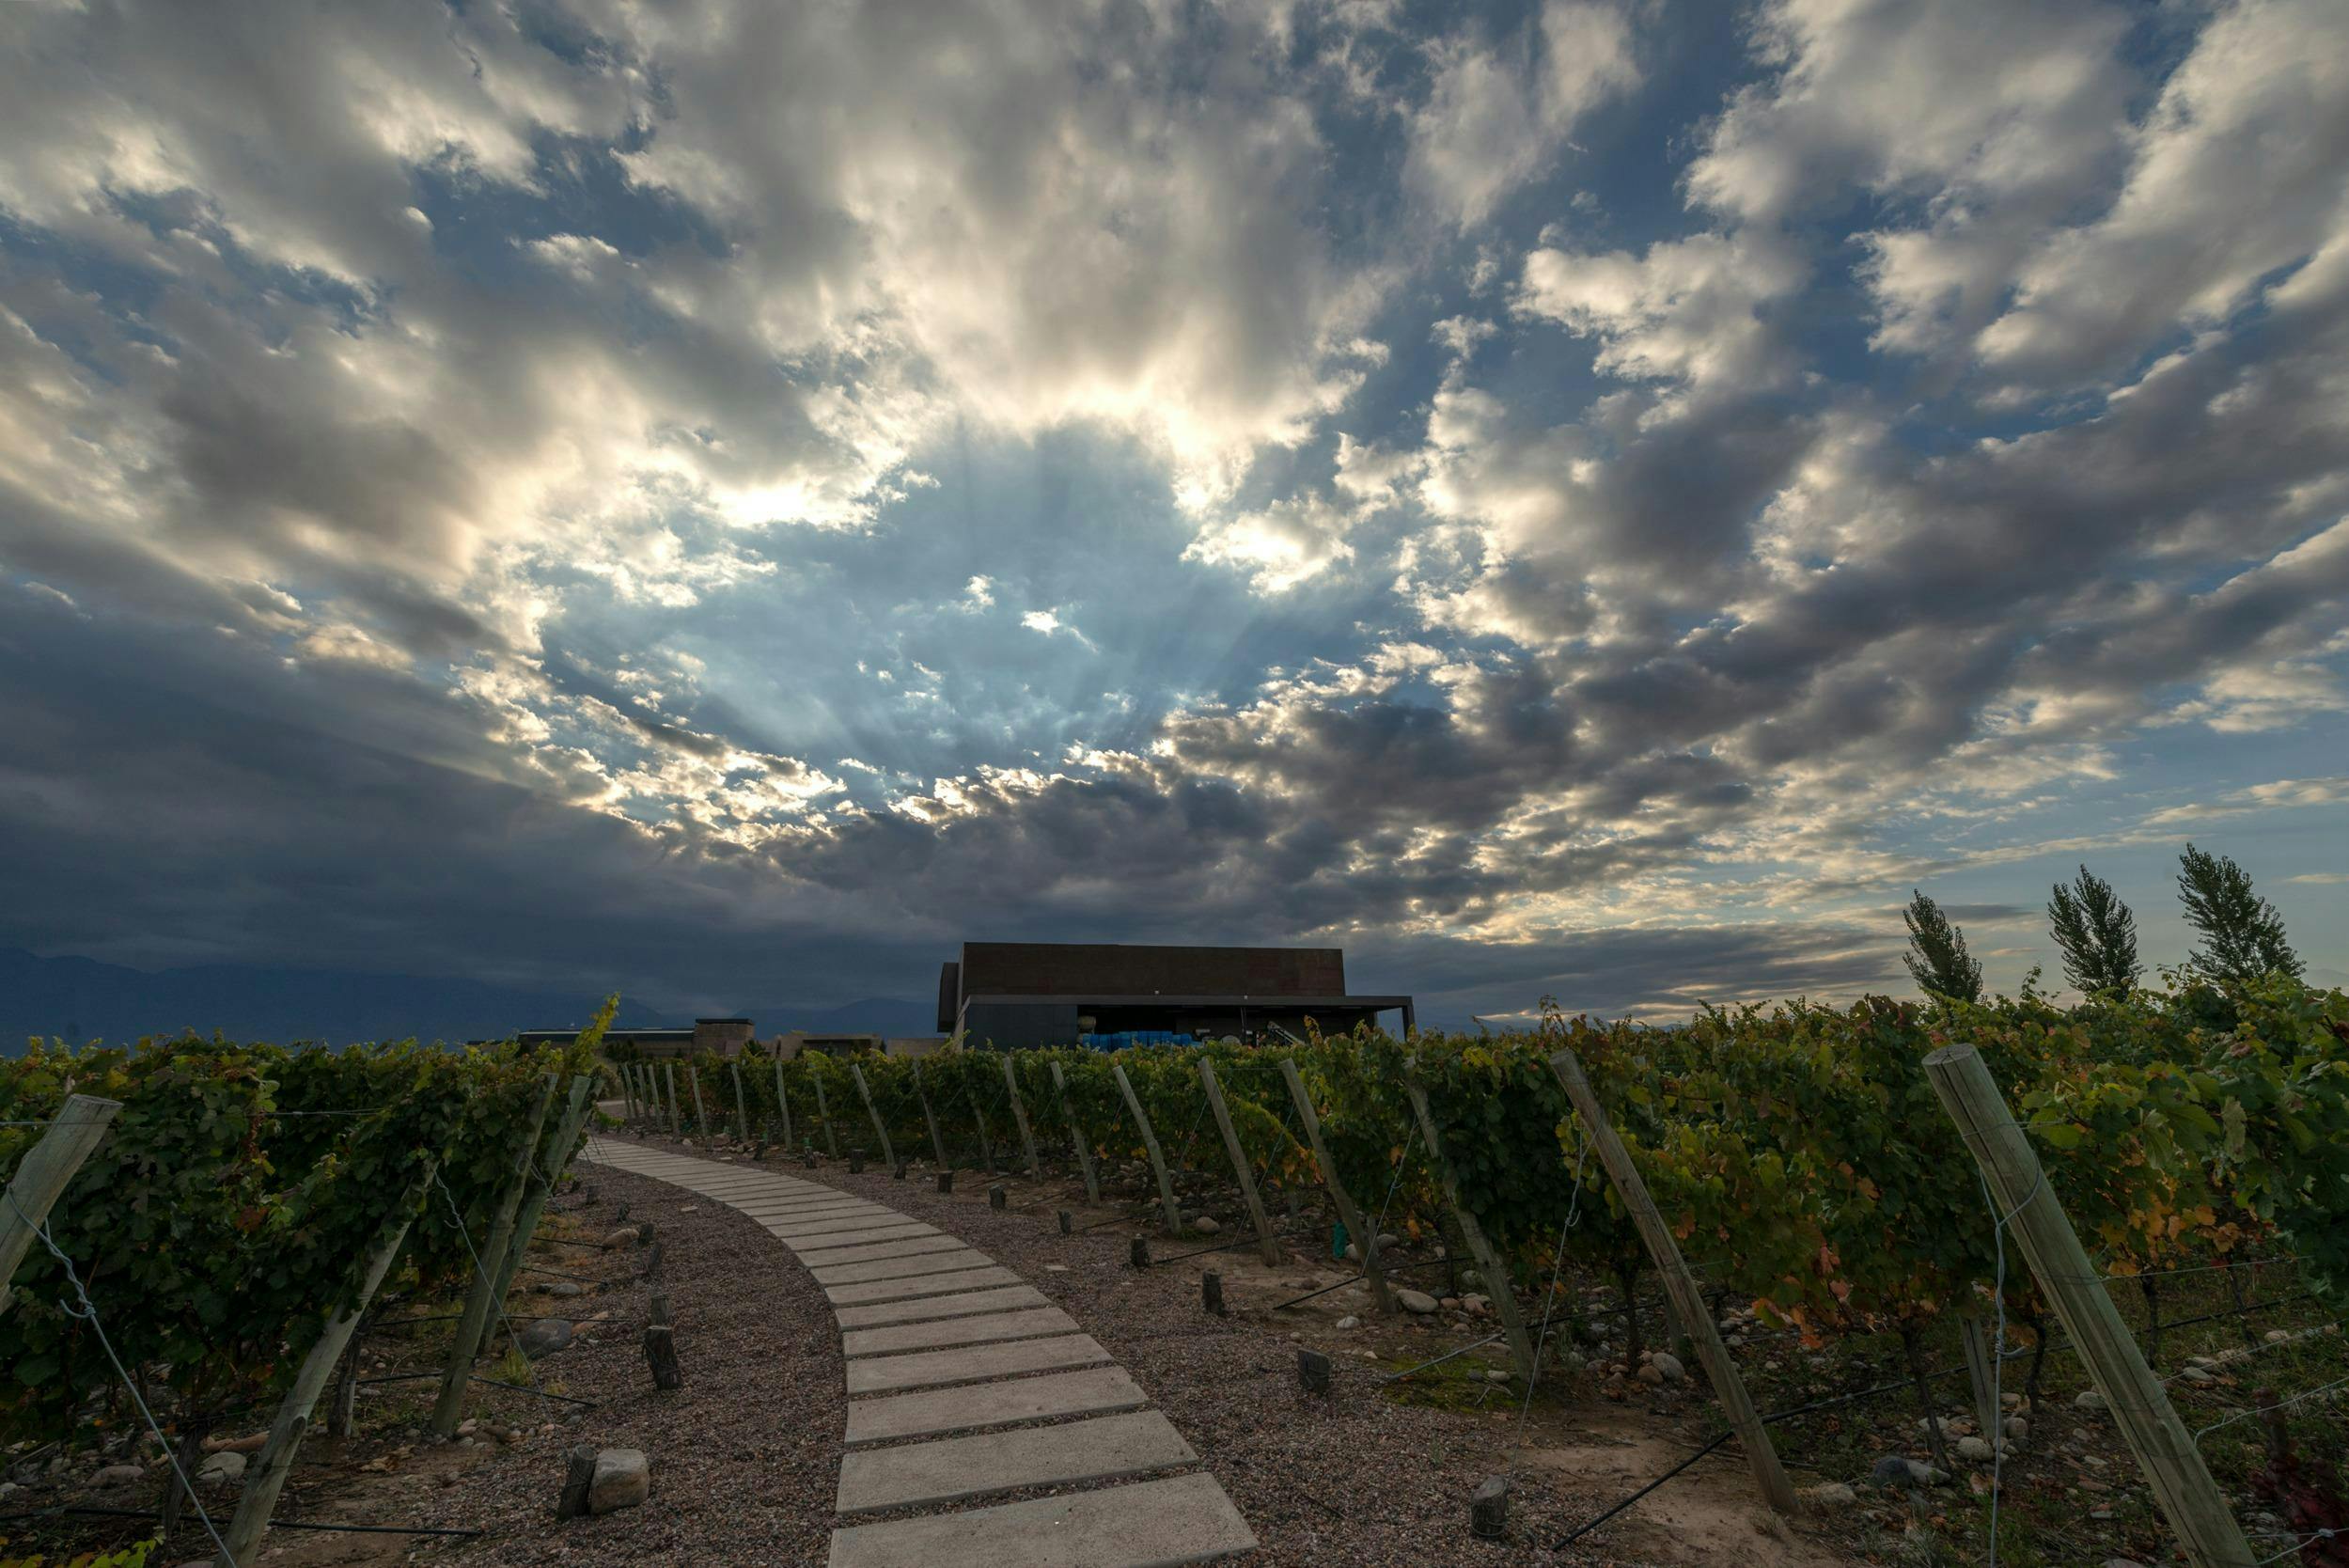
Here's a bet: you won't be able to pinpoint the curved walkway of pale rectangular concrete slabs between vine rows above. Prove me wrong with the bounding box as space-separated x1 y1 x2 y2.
587 1137 1257 1568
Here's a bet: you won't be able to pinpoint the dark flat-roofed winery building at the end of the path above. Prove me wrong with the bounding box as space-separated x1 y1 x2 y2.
937 943 1417 1046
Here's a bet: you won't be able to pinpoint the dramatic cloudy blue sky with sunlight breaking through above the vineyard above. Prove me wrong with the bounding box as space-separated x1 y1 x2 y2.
0 0 2349 1018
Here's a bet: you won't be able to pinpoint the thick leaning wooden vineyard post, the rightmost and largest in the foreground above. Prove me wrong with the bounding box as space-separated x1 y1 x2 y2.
1924 1043 2253 1568
